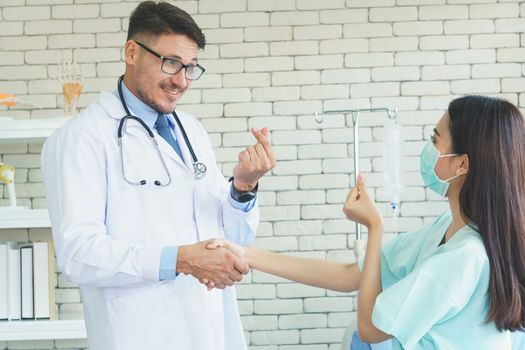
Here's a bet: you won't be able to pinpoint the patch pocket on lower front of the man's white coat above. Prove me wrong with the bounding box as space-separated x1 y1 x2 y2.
109 282 190 350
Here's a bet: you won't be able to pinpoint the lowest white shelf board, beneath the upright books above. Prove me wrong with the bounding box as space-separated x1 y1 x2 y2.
0 320 86 341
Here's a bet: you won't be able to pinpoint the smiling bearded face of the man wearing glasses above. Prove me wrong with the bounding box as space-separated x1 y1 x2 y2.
124 34 199 113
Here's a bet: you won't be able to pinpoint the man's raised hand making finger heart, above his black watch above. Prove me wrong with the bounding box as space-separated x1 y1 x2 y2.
233 128 275 191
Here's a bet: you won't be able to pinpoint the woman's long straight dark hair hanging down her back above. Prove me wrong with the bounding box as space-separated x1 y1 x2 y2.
448 96 525 330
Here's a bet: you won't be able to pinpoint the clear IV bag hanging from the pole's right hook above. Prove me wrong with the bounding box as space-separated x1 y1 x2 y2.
383 118 404 212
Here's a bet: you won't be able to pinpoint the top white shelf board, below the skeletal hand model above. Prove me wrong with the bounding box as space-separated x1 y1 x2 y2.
0 117 71 143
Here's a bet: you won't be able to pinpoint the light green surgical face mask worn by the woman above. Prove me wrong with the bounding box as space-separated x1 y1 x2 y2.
419 141 459 197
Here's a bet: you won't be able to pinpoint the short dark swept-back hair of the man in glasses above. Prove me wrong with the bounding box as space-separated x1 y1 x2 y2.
127 1 206 49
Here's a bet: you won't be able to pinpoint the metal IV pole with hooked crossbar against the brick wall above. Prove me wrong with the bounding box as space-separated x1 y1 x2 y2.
314 108 397 261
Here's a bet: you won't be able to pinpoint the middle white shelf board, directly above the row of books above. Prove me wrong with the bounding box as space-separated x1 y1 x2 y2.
0 207 51 229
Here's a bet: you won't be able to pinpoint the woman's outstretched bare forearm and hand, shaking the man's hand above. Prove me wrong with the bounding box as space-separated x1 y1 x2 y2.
205 240 361 292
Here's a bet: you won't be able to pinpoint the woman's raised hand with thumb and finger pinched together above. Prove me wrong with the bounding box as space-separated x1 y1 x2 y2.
343 174 383 232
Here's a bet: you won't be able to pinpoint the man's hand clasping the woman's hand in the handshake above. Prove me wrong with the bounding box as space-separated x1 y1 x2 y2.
177 240 250 289
